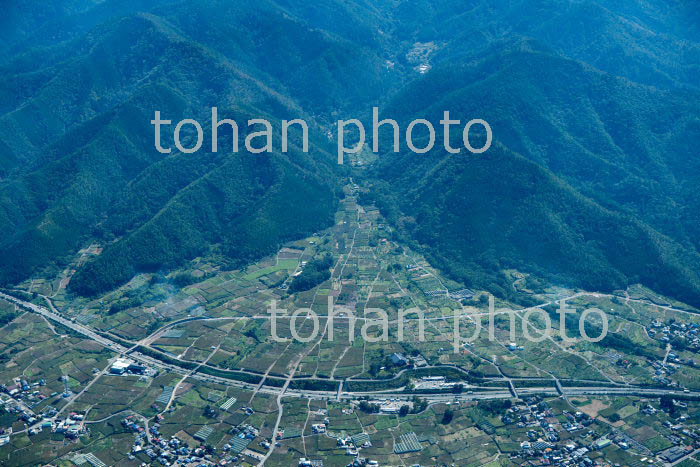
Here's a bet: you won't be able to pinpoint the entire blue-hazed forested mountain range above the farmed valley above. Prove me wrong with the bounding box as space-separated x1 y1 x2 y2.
0 0 700 305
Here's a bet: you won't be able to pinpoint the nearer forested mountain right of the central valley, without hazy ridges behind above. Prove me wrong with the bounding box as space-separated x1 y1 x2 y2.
366 43 700 299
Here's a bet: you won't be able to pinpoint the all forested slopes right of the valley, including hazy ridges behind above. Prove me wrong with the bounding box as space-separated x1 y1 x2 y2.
366 1 700 303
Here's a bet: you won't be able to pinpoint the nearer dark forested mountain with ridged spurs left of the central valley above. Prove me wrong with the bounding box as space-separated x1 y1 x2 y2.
0 2 378 293
